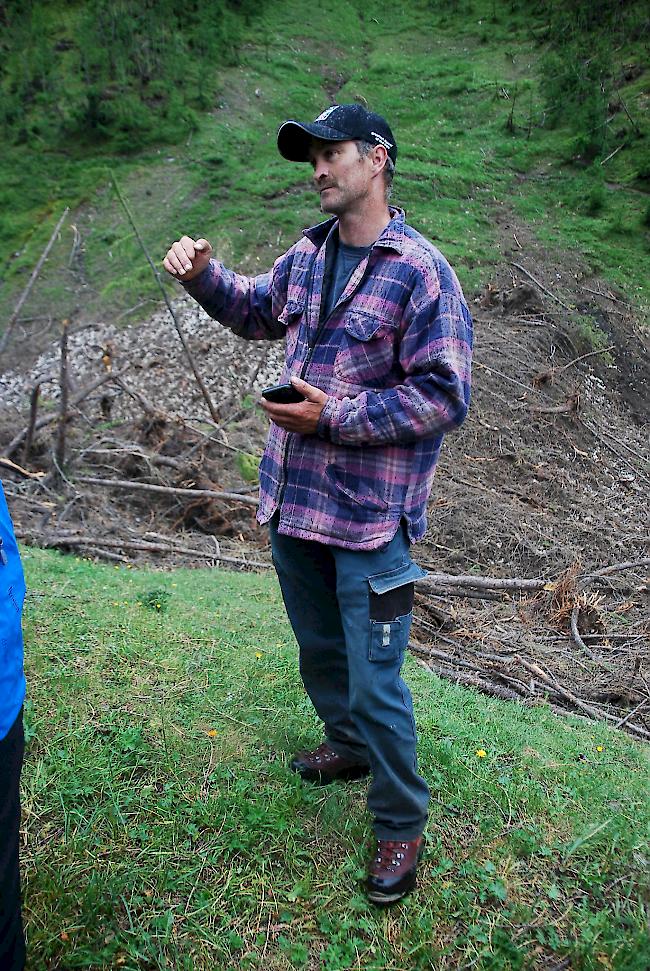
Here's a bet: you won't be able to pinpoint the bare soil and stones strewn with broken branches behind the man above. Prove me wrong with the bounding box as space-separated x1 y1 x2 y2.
0 207 650 739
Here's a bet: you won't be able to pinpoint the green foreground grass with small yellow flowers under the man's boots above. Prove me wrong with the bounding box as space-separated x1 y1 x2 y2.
23 550 650 971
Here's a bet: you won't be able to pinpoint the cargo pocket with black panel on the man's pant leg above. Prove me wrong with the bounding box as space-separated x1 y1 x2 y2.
368 561 426 661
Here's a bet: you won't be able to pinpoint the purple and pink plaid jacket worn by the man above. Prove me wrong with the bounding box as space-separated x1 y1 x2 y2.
184 209 472 549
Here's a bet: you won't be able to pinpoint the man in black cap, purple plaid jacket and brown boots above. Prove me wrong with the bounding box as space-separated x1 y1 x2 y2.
163 105 472 904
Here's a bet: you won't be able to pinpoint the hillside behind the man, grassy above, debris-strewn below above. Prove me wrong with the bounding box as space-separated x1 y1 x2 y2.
0 2 650 737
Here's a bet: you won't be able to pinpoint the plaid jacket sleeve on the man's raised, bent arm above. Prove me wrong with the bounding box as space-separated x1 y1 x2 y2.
179 247 293 340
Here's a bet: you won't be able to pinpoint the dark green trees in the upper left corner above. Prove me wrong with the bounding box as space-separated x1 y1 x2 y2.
0 0 259 151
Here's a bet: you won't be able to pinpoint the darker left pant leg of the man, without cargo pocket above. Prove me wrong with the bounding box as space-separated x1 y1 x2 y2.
270 517 367 762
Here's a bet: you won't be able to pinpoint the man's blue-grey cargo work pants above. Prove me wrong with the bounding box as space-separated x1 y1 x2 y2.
270 513 429 840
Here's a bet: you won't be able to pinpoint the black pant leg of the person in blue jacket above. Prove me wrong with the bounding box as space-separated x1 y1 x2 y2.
0 711 25 971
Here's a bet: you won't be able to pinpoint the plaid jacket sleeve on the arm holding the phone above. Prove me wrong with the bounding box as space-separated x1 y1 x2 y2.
318 284 472 445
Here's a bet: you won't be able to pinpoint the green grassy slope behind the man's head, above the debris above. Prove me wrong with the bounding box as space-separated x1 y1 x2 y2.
0 0 650 330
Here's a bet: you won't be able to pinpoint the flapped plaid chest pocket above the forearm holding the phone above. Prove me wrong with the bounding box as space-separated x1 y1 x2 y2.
334 311 397 388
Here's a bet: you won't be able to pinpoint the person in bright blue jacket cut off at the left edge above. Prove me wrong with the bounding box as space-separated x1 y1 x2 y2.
0 483 25 971
